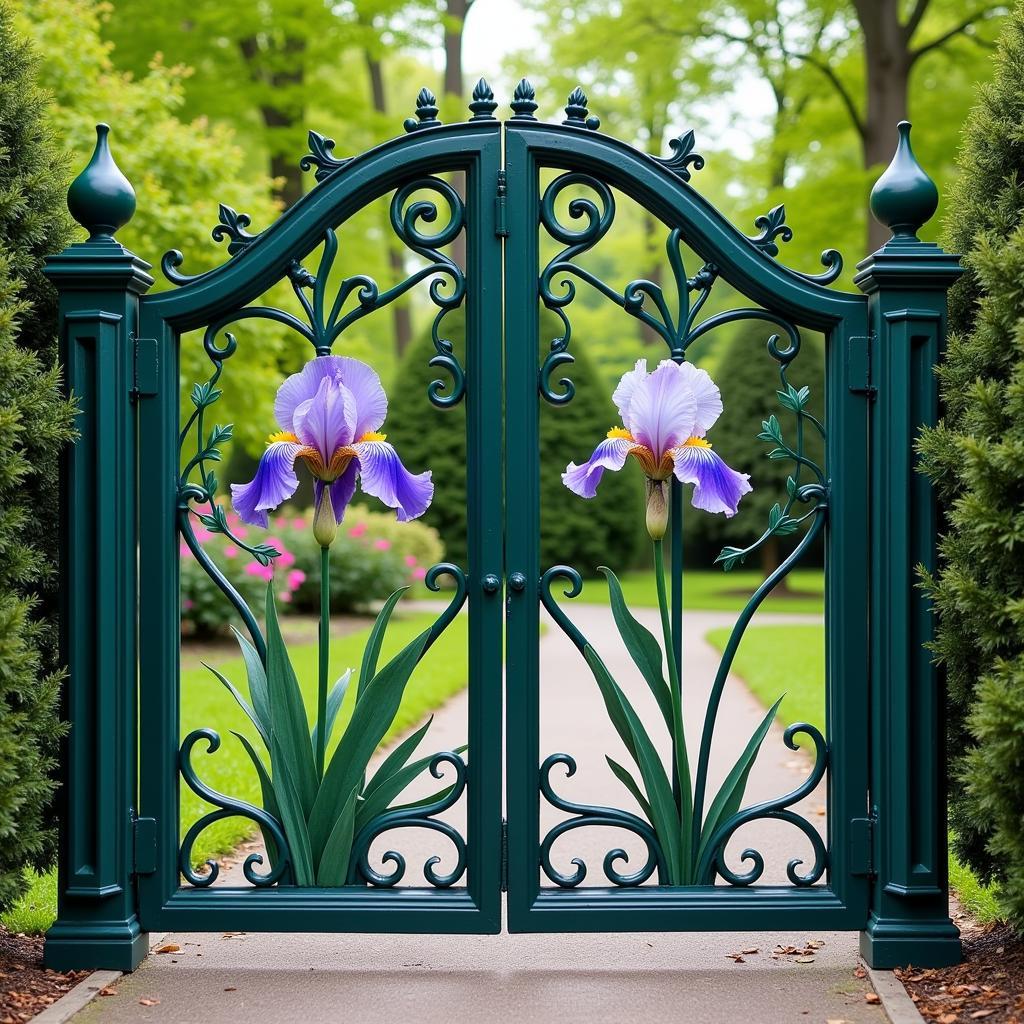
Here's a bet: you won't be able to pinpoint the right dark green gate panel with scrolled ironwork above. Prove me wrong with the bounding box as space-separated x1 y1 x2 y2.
505 116 869 931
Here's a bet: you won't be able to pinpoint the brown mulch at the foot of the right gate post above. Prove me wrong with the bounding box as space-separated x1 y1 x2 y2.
896 921 1024 1024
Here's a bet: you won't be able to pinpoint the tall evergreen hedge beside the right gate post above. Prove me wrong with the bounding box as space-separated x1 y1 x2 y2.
920 6 1024 927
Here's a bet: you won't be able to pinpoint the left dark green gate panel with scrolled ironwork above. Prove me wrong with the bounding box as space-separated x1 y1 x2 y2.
138 121 503 932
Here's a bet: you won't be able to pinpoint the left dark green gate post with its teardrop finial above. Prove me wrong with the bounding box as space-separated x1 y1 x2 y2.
45 125 153 971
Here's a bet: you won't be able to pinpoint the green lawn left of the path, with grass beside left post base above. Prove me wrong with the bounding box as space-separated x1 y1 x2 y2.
0 595 466 933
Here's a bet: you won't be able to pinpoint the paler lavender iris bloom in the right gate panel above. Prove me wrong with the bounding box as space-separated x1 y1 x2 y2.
562 359 752 516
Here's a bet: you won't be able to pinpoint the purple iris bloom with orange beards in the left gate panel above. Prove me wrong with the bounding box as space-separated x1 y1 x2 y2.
231 355 434 544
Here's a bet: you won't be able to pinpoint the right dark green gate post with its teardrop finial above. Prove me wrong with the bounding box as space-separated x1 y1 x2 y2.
854 122 962 968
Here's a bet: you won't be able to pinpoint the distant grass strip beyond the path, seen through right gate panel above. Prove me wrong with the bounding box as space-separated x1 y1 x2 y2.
577 569 824 614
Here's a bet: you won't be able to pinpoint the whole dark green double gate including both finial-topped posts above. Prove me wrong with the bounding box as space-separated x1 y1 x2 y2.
46 81 958 968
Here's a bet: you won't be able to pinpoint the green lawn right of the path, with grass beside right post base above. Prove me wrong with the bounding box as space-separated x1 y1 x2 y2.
708 626 1000 923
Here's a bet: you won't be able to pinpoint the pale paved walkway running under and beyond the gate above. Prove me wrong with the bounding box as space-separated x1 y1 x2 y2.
75 605 885 1024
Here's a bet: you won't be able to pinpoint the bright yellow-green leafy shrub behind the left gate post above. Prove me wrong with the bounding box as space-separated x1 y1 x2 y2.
19 0 296 450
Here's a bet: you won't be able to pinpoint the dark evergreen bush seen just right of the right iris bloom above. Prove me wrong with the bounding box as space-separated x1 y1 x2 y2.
689 323 824 574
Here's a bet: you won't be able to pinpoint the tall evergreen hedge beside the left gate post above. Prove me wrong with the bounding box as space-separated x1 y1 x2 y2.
0 3 73 908
